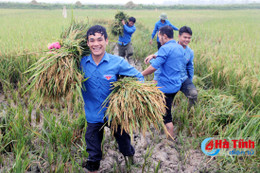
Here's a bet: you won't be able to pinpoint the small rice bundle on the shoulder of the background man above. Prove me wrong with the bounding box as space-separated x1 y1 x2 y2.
111 11 129 36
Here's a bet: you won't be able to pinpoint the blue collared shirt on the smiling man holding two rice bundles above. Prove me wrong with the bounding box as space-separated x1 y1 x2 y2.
81 53 144 123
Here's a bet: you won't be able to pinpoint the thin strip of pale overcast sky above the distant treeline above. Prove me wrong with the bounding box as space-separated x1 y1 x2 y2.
0 0 260 4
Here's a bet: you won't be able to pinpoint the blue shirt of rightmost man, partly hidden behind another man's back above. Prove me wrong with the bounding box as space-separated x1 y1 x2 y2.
150 46 194 83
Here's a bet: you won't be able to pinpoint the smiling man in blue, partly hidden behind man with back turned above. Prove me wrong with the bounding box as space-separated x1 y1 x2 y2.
146 26 198 111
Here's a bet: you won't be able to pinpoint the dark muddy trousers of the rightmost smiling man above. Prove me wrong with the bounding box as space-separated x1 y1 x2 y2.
180 78 198 111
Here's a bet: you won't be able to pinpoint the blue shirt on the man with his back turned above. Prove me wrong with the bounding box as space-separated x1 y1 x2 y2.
151 40 186 93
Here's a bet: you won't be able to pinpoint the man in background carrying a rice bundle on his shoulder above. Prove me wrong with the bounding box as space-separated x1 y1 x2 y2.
118 17 136 61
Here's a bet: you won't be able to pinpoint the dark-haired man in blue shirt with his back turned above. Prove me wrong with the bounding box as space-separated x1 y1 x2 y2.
142 26 185 137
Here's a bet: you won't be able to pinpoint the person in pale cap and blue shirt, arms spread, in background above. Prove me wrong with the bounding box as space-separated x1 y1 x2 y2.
149 13 178 50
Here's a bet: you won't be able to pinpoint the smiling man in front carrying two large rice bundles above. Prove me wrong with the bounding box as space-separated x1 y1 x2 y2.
81 25 143 172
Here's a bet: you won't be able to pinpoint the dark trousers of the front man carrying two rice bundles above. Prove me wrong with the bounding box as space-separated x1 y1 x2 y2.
85 123 135 171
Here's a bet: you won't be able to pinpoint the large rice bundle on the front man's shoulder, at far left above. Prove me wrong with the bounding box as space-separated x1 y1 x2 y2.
26 21 90 101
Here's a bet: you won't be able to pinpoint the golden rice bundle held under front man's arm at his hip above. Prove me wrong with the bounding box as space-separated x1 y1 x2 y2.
104 77 168 136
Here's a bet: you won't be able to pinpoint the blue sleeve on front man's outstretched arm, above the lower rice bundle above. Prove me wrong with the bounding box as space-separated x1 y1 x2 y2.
119 59 144 81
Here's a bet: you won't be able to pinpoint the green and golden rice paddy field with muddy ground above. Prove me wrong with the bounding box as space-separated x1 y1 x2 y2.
0 9 260 173
